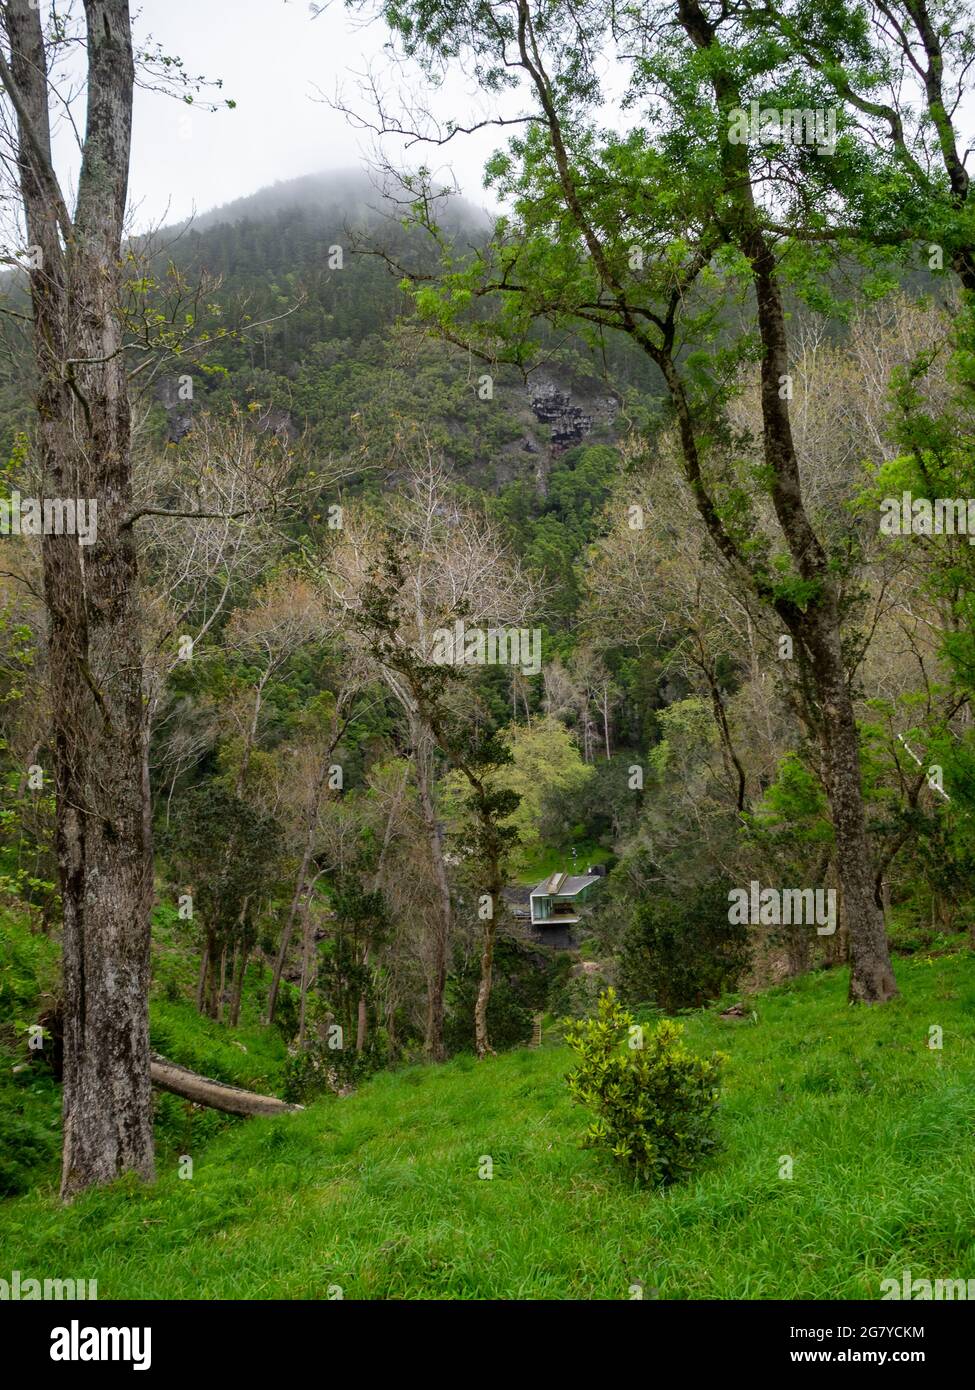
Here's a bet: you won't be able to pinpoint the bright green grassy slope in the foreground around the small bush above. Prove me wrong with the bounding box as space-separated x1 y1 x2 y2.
0 954 975 1298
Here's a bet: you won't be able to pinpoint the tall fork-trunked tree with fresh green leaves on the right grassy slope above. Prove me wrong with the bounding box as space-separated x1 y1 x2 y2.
350 0 896 1002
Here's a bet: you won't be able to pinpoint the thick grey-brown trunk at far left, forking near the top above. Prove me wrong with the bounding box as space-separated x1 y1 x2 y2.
3 0 153 1198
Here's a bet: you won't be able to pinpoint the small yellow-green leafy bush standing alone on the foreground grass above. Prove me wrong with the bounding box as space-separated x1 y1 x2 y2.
565 990 725 1187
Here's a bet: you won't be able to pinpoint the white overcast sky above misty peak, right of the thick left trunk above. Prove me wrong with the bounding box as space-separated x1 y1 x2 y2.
118 0 503 227
